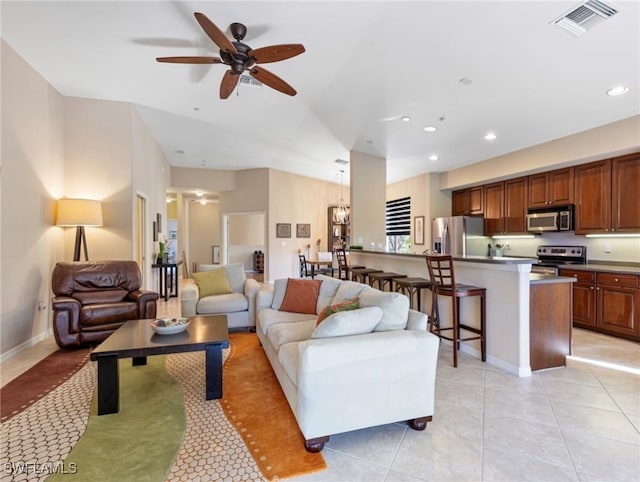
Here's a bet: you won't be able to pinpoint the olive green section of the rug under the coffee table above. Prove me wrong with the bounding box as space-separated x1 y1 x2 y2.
47 356 185 482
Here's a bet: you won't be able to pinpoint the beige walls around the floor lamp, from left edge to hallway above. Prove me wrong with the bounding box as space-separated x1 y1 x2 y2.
0 42 168 359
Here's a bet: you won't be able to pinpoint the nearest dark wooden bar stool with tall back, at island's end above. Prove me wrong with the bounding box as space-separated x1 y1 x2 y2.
425 256 487 367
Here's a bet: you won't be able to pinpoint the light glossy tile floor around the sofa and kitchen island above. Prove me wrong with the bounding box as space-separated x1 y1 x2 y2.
0 299 640 482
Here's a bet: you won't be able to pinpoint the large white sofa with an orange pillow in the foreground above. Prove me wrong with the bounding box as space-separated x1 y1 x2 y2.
256 275 439 452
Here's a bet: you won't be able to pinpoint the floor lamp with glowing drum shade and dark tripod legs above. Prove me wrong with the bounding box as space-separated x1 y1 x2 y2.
56 199 102 261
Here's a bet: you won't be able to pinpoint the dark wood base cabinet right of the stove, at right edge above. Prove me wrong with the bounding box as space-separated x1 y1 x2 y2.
560 269 640 341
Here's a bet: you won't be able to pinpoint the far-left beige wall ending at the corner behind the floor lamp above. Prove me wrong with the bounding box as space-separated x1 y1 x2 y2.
0 41 65 359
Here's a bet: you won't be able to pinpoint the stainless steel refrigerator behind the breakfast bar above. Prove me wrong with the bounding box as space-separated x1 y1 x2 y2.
431 216 491 256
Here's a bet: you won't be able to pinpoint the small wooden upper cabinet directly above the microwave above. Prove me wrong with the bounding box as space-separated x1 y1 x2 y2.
528 167 574 208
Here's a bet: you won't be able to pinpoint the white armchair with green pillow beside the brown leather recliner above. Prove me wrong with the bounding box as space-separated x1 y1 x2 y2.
180 263 260 328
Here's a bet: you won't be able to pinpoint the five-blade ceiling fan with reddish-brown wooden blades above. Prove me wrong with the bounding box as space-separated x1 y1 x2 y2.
156 12 304 99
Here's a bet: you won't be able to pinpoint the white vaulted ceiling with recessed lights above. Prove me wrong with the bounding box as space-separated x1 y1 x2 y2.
1 0 640 182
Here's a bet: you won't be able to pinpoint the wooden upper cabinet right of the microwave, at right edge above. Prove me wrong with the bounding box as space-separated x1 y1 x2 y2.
575 153 640 234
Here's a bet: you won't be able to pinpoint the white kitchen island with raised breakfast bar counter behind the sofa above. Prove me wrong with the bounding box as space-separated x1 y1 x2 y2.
350 250 573 377
